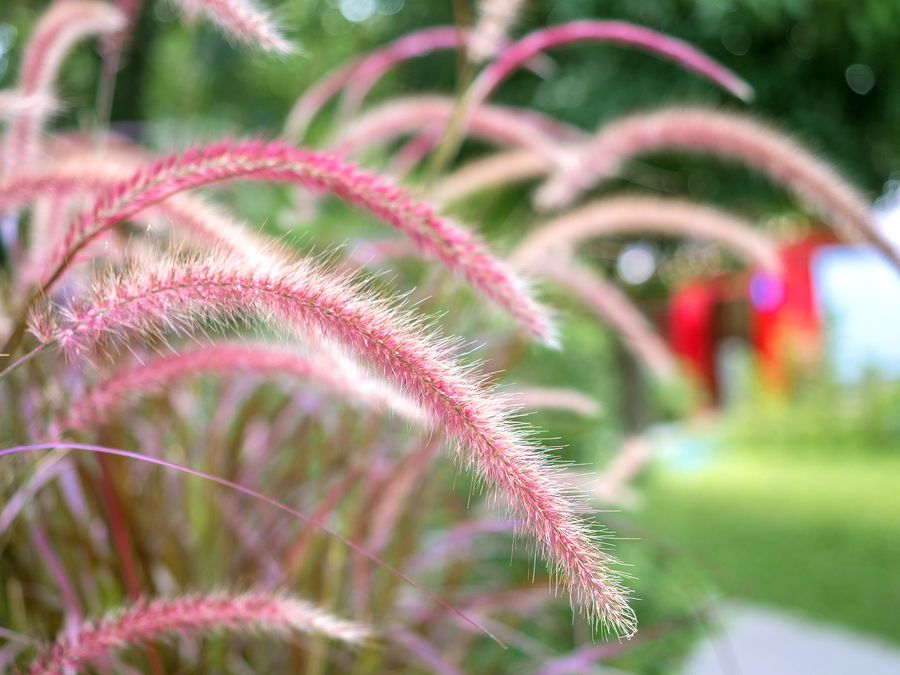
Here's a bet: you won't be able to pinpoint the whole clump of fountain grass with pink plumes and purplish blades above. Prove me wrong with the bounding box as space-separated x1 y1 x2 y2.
0 0 884 675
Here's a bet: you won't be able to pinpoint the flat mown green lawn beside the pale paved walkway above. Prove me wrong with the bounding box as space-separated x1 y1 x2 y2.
634 447 900 643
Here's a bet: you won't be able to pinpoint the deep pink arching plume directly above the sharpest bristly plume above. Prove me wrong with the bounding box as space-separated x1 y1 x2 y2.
45 141 556 346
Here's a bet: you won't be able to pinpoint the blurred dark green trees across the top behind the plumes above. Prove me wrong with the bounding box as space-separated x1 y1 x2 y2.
0 0 900 198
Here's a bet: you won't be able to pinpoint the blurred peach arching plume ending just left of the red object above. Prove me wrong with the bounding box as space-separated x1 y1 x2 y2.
512 197 781 274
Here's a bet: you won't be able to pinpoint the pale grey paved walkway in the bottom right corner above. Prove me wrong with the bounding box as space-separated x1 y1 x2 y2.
682 603 900 675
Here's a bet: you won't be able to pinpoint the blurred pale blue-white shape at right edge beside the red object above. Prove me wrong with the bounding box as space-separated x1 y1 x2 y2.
812 246 900 384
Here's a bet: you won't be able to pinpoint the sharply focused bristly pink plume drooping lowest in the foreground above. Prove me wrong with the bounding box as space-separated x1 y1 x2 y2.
38 259 634 634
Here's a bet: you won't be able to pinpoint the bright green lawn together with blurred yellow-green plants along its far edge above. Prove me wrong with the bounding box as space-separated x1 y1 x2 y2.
635 380 900 642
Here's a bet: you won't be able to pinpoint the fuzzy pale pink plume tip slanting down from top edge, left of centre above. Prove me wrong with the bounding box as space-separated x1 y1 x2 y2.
170 0 296 56
